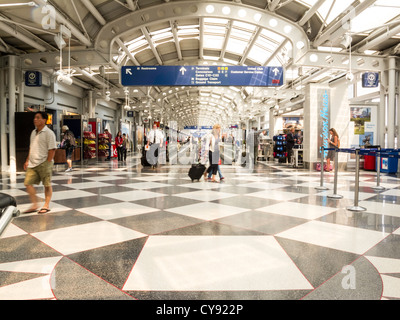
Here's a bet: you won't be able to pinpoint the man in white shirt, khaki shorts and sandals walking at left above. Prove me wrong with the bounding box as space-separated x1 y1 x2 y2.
23 112 57 214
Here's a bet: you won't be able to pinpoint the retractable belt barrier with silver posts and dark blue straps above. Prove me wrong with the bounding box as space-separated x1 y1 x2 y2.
316 147 400 211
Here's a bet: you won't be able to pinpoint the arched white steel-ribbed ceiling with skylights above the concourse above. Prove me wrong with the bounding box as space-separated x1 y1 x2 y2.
0 0 400 126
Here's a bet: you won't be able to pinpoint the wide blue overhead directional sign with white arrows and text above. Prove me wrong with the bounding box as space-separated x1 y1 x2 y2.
121 66 284 87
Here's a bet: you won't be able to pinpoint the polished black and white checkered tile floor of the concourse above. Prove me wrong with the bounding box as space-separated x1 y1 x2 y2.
0 159 400 300
